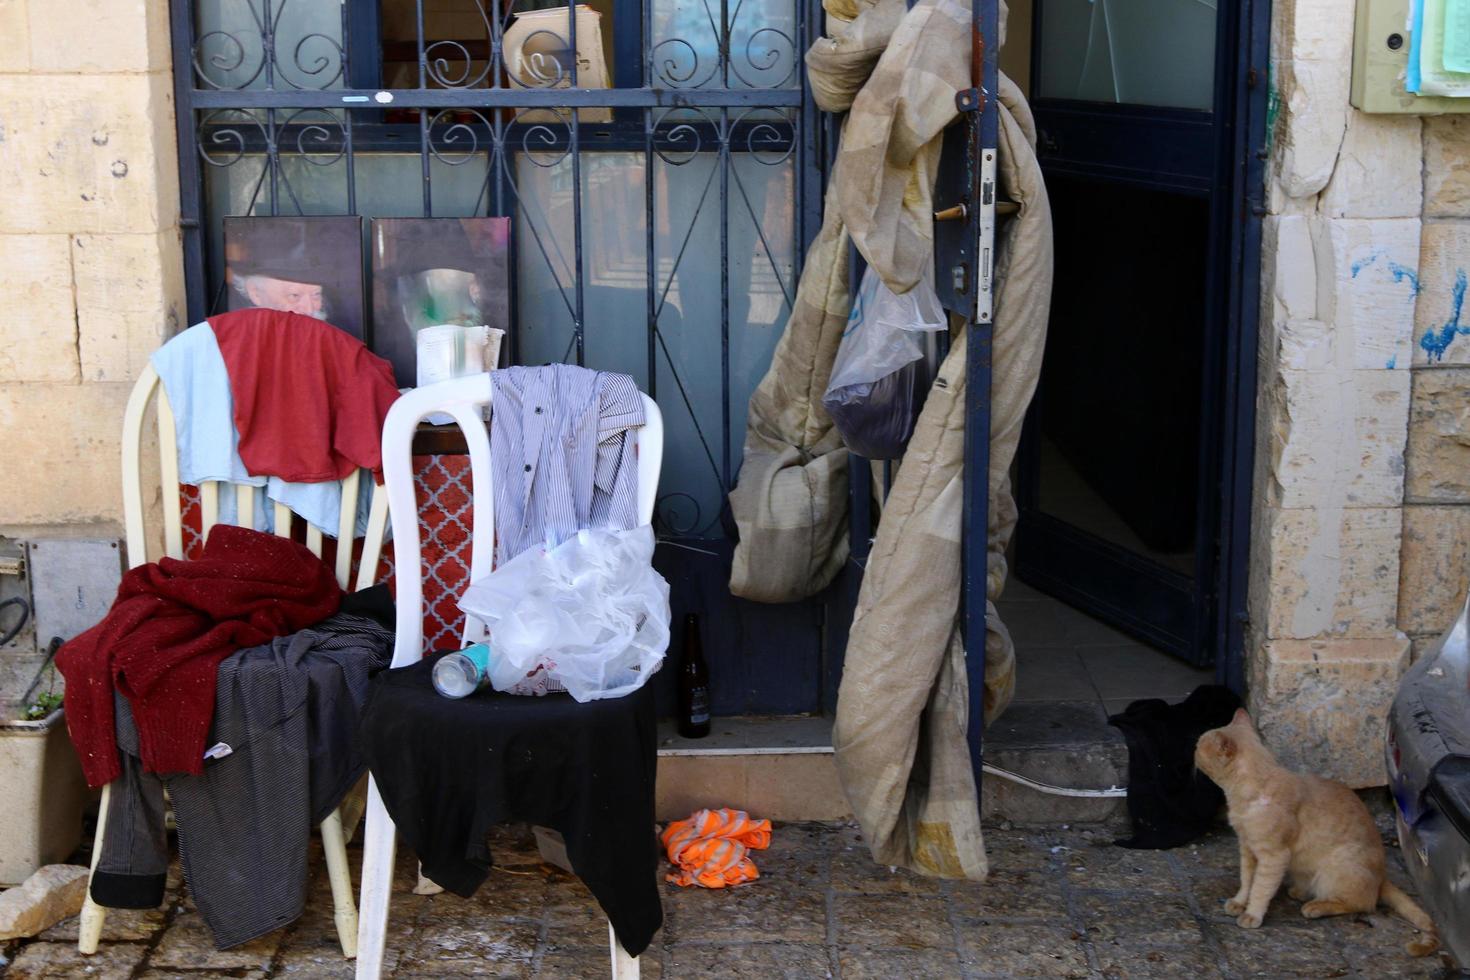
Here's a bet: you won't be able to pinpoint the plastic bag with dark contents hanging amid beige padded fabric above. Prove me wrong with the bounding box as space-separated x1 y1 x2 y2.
822 267 947 460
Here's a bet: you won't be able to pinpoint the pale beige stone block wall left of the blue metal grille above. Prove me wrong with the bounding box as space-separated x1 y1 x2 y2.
0 0 184 526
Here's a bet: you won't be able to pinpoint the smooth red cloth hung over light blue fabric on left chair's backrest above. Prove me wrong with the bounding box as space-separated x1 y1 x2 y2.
209 310 398 483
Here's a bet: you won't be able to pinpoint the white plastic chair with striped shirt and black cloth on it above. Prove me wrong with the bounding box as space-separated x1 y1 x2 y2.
357 373 663 980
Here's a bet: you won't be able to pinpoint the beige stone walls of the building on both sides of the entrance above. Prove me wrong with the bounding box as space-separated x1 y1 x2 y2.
0 0 1470 785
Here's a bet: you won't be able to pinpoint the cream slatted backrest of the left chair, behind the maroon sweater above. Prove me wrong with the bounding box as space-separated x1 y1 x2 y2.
122 364 388 589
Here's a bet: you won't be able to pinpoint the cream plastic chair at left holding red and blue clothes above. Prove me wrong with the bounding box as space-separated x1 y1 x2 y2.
76 366 388 959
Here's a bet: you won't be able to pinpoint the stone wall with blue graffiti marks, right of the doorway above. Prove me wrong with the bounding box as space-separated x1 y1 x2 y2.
1248 0 1470 786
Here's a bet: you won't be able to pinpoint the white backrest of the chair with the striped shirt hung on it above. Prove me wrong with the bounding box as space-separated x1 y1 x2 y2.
382 373 663 667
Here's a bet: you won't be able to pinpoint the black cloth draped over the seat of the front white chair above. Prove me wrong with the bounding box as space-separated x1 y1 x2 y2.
362 652 663 956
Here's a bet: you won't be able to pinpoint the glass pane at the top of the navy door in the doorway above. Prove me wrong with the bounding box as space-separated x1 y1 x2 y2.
1041 0 1216 110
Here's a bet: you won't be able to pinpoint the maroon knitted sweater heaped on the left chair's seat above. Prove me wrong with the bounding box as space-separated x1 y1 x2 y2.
56 525 343 786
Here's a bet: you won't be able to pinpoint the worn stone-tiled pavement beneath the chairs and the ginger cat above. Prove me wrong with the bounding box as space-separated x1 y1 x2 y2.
0 824 1445 980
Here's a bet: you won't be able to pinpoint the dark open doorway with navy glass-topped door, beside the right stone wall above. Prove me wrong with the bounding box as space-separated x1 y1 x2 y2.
1014 0 1261 679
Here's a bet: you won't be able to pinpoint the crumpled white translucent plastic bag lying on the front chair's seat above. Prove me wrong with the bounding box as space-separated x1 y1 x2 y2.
460 525 669 701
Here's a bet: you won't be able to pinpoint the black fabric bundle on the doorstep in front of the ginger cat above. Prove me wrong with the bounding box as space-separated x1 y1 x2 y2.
1107 685 1241 851
